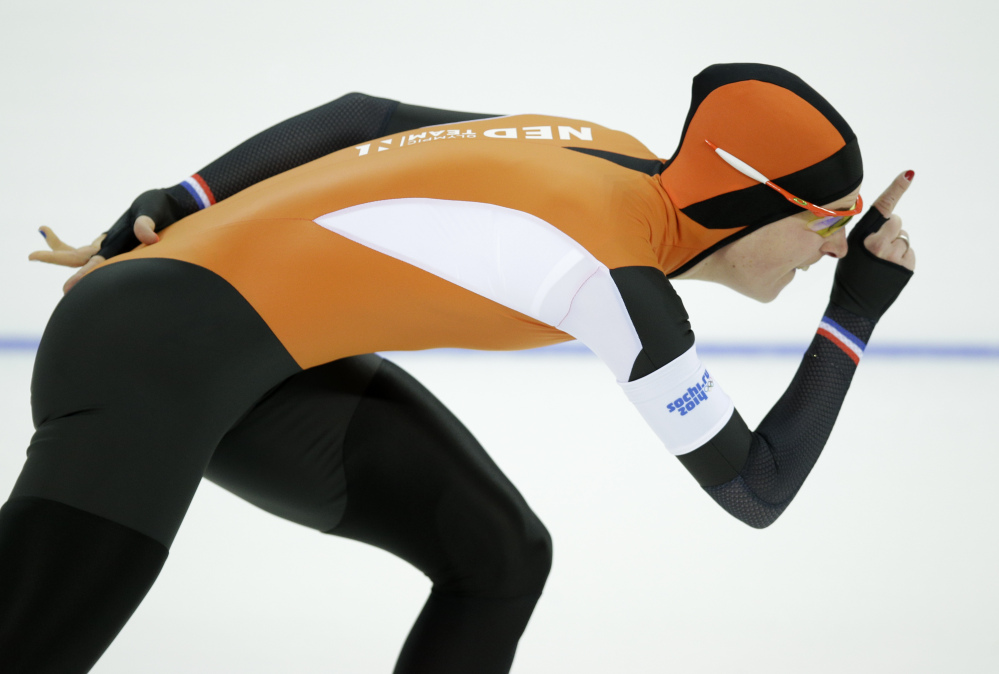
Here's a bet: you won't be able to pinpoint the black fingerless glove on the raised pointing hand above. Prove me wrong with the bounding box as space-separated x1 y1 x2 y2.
830 201 912 321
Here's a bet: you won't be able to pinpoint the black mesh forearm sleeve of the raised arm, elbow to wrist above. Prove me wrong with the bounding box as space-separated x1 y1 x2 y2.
704 304 875 528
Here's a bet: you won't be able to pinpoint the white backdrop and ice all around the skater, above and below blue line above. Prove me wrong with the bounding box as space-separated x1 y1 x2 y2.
0 0 999 674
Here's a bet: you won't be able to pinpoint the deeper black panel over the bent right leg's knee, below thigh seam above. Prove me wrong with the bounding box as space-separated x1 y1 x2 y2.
342 362 552 674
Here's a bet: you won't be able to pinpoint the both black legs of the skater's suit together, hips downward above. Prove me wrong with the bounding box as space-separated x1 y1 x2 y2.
0 276 552 674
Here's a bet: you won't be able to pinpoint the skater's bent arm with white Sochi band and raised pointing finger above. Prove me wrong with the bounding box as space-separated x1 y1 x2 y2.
615 176 915 528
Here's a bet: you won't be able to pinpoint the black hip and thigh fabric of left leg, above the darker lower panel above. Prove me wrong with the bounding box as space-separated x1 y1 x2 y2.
11 259 301 547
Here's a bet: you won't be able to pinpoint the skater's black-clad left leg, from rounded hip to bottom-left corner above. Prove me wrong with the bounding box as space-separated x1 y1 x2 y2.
0 259 300 674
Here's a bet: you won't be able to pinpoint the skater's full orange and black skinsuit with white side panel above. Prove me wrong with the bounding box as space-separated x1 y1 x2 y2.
0 65 907 673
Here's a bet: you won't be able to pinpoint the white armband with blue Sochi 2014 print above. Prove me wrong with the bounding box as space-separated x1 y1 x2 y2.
619 346 735 456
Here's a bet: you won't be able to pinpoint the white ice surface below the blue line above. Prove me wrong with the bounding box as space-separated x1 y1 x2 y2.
0 353 999 674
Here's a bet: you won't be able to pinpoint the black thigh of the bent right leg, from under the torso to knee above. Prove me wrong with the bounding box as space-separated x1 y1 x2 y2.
206 355 550 592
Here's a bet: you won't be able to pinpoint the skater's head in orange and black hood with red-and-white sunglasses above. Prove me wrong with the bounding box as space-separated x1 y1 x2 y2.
661 63 863 301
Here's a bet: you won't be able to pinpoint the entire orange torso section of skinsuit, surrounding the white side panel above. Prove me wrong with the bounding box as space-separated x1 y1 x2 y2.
99 115 688 367
